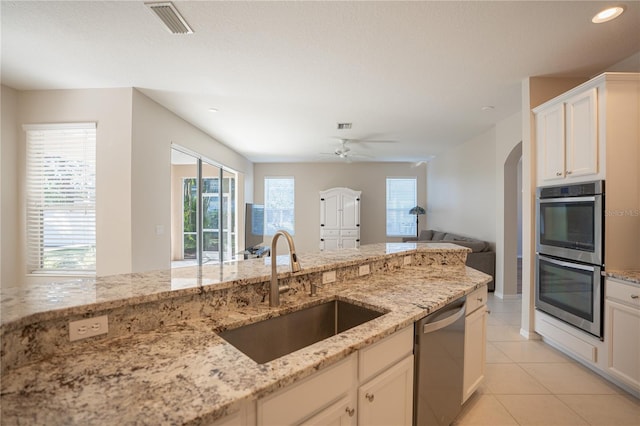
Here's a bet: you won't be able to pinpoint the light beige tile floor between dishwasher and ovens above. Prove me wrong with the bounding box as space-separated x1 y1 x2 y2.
453 293 640 426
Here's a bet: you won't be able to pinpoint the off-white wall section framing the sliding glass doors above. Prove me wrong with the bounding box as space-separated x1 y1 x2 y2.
131 90 253 272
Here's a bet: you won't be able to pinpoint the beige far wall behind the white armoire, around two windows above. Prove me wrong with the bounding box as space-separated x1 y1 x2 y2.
254 162 426 253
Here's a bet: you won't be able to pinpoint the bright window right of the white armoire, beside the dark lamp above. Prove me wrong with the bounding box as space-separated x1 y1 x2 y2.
387 178 418 237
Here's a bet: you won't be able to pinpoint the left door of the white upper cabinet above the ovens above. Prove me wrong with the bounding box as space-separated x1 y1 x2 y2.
536 103 565 181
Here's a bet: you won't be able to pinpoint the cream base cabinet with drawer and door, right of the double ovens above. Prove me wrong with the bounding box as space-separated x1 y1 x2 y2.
605 278 640 392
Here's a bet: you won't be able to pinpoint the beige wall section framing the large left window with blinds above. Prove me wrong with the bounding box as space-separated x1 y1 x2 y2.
16 88 132 275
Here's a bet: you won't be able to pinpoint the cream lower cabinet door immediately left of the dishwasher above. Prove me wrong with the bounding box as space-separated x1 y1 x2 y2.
358 355 413 426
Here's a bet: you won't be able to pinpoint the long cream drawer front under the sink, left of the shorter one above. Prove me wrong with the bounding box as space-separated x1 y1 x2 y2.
257 354 357 425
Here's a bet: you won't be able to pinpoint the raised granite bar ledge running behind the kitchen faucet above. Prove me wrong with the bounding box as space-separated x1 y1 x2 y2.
0 243 424 327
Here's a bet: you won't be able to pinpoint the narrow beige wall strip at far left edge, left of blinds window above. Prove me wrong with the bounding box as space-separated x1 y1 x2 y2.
0 86 23 285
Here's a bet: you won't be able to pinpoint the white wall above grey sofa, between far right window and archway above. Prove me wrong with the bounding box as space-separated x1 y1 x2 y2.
427 128 496 244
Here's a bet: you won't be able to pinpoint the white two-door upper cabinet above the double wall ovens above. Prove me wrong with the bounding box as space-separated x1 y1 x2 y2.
533 73 638 186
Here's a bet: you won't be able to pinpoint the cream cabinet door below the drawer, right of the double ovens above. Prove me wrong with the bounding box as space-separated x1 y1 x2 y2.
605 298 640 391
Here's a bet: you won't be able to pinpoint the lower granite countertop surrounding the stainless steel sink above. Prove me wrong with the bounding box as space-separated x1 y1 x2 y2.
1 243 490 425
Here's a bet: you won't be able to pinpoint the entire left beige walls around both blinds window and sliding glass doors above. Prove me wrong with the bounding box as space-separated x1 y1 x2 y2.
0 87 253 285
